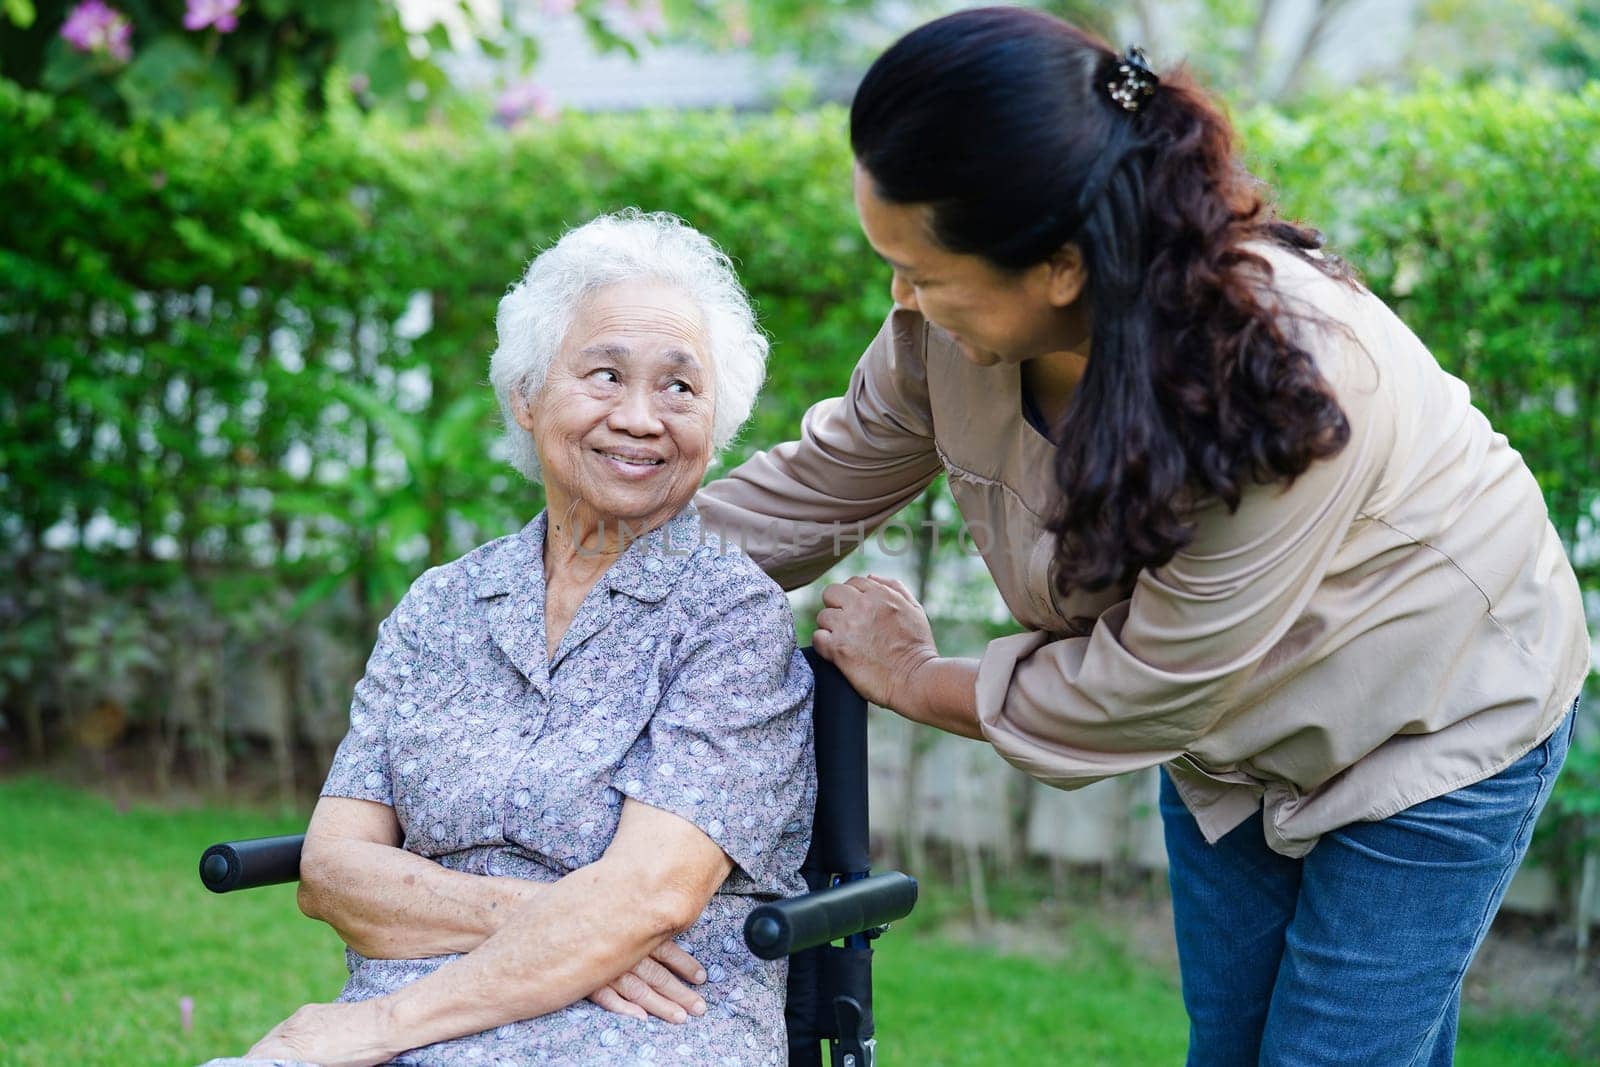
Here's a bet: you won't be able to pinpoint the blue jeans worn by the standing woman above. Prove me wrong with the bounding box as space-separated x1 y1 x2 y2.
1160 703 1576 1067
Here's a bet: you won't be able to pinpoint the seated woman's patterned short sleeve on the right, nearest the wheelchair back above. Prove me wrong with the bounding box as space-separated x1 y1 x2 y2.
611 568 816 894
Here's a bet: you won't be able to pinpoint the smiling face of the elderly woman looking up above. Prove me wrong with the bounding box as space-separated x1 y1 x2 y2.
517 282 715 523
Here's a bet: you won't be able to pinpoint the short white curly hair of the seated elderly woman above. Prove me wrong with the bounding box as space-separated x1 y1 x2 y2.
490 208 768 482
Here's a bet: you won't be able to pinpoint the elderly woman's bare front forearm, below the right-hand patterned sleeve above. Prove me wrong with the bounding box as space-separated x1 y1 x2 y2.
379 800 733 1054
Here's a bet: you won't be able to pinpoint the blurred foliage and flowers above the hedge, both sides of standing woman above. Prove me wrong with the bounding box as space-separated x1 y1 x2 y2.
9 0 1600 120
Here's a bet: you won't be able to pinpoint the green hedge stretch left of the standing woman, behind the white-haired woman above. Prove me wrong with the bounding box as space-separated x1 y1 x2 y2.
0 83 886 601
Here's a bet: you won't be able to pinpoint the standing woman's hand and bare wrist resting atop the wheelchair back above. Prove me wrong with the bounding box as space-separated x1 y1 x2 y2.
811 574 984 737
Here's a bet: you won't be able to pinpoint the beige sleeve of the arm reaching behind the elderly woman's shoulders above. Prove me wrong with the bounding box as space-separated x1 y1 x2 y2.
694 310 941 589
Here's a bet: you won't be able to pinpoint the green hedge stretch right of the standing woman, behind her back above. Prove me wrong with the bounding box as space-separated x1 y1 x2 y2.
1248 82 1600 563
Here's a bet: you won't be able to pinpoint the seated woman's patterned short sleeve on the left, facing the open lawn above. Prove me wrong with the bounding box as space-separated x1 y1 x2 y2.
322 597 416 808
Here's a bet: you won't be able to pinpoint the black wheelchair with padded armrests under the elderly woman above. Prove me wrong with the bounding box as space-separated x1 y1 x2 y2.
200 648 917 1067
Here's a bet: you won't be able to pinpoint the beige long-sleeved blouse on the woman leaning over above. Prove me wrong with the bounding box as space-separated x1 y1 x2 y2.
698 248 1589 856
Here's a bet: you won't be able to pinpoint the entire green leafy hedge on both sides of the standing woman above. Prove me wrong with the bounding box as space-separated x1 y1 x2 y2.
0 82 1600 851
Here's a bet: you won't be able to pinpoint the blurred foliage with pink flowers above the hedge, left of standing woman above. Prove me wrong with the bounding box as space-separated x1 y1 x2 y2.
0 0 902 118
